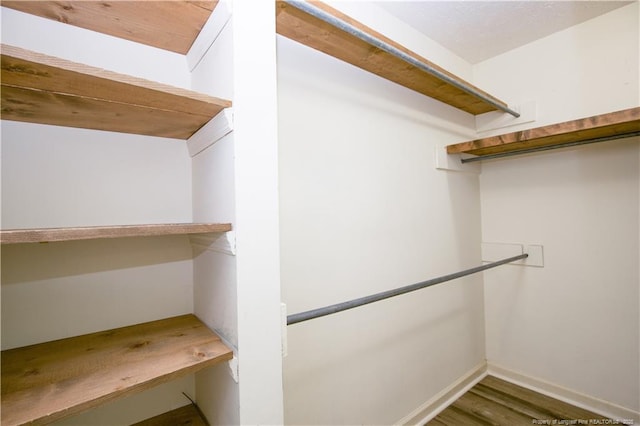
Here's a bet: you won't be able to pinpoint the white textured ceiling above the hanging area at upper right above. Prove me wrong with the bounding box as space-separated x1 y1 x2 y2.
375 0 633 64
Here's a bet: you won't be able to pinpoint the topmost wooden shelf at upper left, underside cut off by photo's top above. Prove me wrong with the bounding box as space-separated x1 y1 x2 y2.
2 0 218 54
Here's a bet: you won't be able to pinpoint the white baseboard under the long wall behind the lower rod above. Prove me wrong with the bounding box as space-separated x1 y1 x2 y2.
395 361 487 425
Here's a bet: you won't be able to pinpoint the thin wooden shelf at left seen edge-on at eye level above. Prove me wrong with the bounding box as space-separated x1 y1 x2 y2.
0 223 231 244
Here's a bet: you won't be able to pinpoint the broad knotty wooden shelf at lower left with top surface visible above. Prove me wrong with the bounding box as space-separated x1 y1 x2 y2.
1 315 233 426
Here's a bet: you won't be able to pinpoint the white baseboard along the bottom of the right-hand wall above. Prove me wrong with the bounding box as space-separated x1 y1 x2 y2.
487 363 640 423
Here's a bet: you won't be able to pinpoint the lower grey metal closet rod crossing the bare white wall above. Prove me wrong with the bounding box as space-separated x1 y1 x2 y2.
287 253 529 325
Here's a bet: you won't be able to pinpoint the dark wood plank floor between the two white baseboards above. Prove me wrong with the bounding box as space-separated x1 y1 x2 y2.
426 376 605 426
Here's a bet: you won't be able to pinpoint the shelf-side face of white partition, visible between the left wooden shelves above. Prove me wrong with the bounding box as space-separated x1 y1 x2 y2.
191 11 240 424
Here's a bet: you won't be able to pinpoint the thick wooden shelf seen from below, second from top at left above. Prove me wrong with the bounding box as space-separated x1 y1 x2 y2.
1 44 231 139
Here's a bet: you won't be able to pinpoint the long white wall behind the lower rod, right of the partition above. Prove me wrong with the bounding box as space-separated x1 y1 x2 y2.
277 5 485 424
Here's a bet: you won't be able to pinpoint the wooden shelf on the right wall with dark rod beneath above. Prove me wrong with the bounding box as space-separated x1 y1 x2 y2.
447 107 640 156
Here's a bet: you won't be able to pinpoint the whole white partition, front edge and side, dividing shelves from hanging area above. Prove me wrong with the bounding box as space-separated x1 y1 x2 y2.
192 2 283 424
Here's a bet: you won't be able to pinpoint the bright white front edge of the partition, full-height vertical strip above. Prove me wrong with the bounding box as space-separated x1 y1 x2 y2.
233 1 283 424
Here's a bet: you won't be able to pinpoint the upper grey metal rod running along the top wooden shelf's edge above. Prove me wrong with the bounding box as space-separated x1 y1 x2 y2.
284 0 520 117
